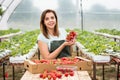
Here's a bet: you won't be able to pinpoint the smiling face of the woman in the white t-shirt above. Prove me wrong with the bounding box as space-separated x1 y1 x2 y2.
44 12 56 29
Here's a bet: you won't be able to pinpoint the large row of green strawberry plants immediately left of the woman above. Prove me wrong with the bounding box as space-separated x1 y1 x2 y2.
0 30 40 56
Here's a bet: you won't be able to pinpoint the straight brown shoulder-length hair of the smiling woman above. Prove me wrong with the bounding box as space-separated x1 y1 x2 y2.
40 9 59 39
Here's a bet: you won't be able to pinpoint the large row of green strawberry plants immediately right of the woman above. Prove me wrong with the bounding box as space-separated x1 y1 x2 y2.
67 29 120 55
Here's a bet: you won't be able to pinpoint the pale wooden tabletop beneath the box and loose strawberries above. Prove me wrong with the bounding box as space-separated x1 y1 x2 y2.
20 71 92 80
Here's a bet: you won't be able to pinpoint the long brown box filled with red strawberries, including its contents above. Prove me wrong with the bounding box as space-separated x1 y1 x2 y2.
24 57 92 74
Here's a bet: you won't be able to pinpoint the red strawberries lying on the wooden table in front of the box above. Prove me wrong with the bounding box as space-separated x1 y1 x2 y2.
39 69 74 80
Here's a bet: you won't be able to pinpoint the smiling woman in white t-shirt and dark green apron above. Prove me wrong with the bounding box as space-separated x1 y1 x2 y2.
38 9 75 59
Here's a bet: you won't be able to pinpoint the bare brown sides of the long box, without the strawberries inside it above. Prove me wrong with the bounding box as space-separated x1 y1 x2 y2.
24 57 92 74
